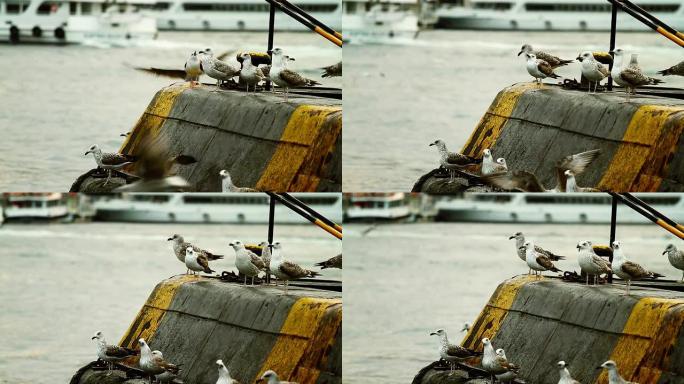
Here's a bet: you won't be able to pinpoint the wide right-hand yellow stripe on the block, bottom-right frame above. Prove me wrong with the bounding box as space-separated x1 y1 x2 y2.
597 297 684 383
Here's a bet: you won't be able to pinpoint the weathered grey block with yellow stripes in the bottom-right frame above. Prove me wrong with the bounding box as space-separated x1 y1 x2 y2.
414 276 684 384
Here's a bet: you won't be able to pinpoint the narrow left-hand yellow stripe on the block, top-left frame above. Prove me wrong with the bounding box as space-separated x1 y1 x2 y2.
119 82 190 153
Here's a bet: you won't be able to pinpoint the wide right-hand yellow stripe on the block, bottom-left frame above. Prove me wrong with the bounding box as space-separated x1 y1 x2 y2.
252 297 342 384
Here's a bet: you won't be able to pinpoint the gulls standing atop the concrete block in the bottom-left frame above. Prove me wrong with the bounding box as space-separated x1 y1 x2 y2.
168 234 342 294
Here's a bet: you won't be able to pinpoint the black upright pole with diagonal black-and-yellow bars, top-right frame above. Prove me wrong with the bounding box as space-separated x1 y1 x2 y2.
607 0 684 91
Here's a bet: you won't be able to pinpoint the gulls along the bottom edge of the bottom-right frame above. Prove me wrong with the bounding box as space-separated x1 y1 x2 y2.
430 329 637 384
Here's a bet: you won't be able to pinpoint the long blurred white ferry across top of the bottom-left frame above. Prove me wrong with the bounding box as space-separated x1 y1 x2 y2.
90 193 342 224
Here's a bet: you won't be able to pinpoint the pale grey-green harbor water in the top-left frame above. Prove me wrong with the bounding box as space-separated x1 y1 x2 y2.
0 32 342 192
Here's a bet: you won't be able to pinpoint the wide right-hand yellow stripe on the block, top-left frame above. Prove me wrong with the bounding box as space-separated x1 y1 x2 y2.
256 105 342 192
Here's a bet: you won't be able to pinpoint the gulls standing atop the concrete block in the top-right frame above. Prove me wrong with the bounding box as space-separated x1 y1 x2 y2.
518 44 684 102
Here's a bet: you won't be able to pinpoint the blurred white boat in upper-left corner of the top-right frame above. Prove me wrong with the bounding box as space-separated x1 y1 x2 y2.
342 0 421 44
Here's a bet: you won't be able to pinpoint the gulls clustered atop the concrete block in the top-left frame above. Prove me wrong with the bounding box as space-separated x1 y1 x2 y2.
179 48 342 101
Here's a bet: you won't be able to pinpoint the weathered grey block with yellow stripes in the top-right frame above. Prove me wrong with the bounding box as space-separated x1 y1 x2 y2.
412 83 684 193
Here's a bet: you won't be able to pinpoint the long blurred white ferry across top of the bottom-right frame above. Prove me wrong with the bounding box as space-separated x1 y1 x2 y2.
435 193 684 224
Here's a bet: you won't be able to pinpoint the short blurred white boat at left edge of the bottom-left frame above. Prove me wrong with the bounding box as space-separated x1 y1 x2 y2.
4 193 69 221
